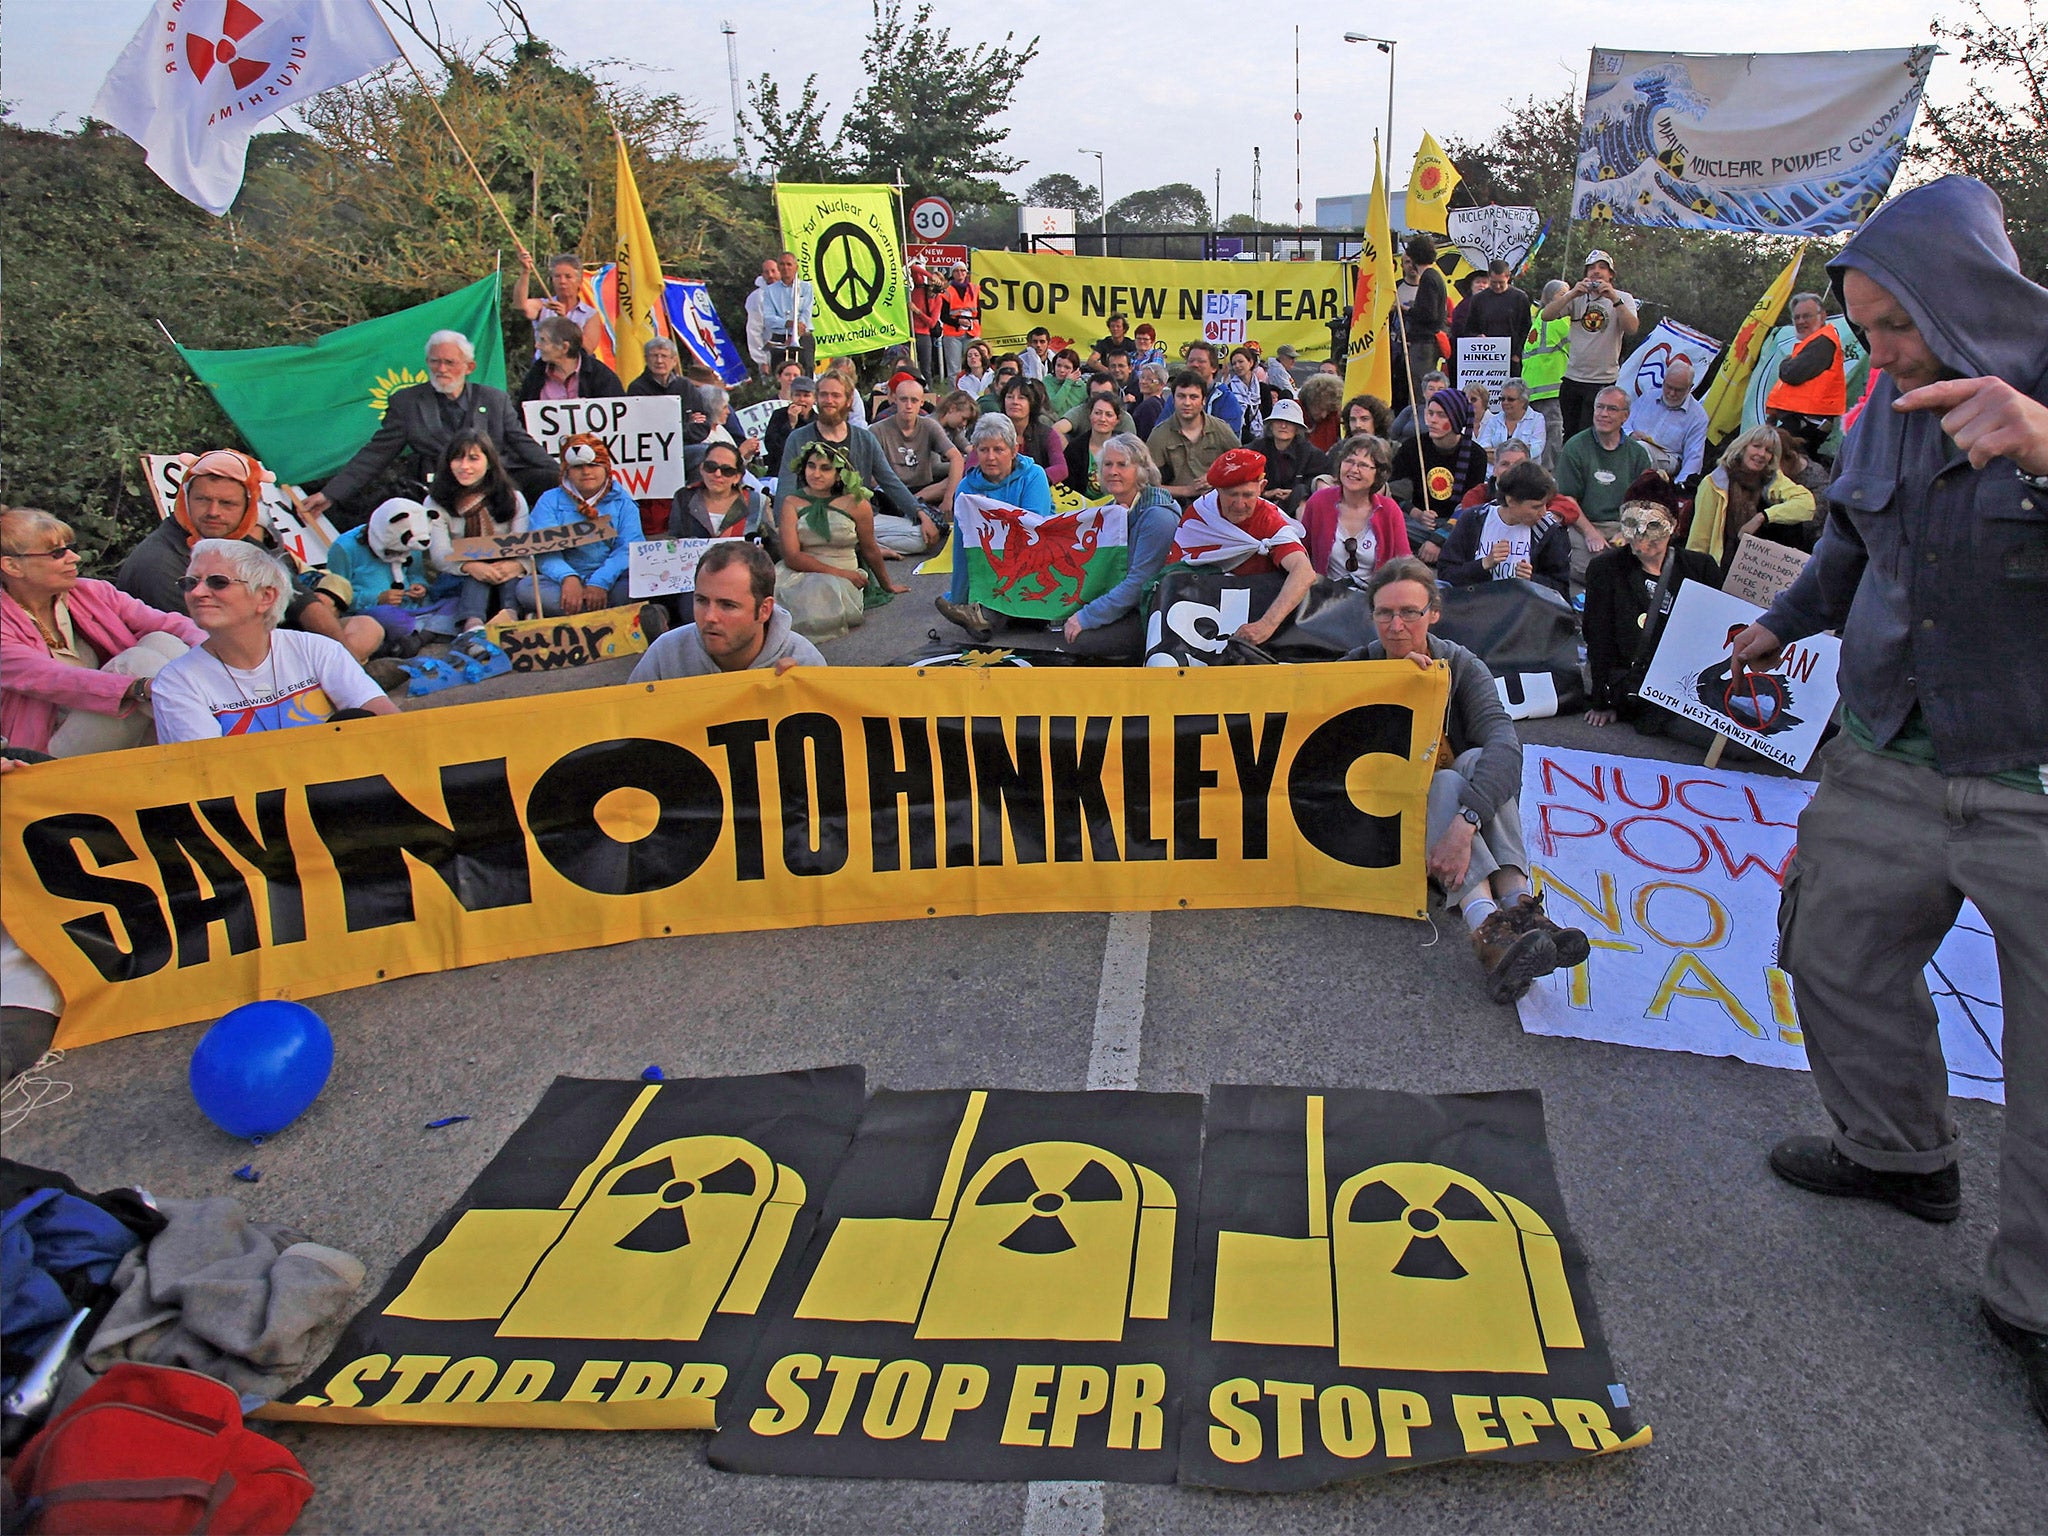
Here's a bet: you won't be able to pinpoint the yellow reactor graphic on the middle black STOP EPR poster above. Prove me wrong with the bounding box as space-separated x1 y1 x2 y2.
797 1092 1176 1339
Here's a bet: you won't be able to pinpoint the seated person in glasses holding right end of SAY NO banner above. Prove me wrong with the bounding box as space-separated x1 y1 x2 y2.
1343 561 1591 1004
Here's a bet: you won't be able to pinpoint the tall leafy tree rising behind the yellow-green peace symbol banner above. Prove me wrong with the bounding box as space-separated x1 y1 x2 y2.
741 0 1038 205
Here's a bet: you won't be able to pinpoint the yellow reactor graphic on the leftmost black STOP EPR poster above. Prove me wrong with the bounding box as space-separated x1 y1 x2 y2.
385 1085 805 1339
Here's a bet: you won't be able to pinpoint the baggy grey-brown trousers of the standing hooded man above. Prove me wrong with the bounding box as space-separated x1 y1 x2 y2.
1778 735 2048 1331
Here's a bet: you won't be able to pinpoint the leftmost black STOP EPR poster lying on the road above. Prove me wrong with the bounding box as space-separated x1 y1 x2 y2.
264 1067 866 1430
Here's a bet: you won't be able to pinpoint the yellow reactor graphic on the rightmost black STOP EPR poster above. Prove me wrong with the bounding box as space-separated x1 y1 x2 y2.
1210 1096 1585 1374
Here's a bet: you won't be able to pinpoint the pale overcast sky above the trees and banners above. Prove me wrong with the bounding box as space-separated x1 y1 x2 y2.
0 0 2025 223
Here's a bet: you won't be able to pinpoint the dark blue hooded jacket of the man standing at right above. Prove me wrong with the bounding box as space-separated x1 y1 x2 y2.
1761 176 2048 776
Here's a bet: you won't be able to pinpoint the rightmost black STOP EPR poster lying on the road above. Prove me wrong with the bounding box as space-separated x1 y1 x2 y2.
1180 1087 1651 1491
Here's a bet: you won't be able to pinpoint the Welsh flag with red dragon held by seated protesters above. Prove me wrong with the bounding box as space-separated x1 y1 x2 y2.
952 489 1130 623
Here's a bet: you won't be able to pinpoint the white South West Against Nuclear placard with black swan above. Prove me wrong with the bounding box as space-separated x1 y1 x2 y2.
1638 582 1841 772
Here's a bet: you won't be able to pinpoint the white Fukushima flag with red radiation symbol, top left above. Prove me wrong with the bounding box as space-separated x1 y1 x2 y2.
92 0 401 215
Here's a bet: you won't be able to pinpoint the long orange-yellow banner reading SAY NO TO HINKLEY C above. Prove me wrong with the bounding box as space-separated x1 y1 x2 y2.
0 662 1448 1047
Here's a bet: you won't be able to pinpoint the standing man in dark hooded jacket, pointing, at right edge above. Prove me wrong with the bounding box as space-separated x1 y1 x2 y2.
1731 176 2048 1419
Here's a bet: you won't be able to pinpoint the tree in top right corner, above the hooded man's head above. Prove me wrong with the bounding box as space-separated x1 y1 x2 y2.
1915 0 2048 283
